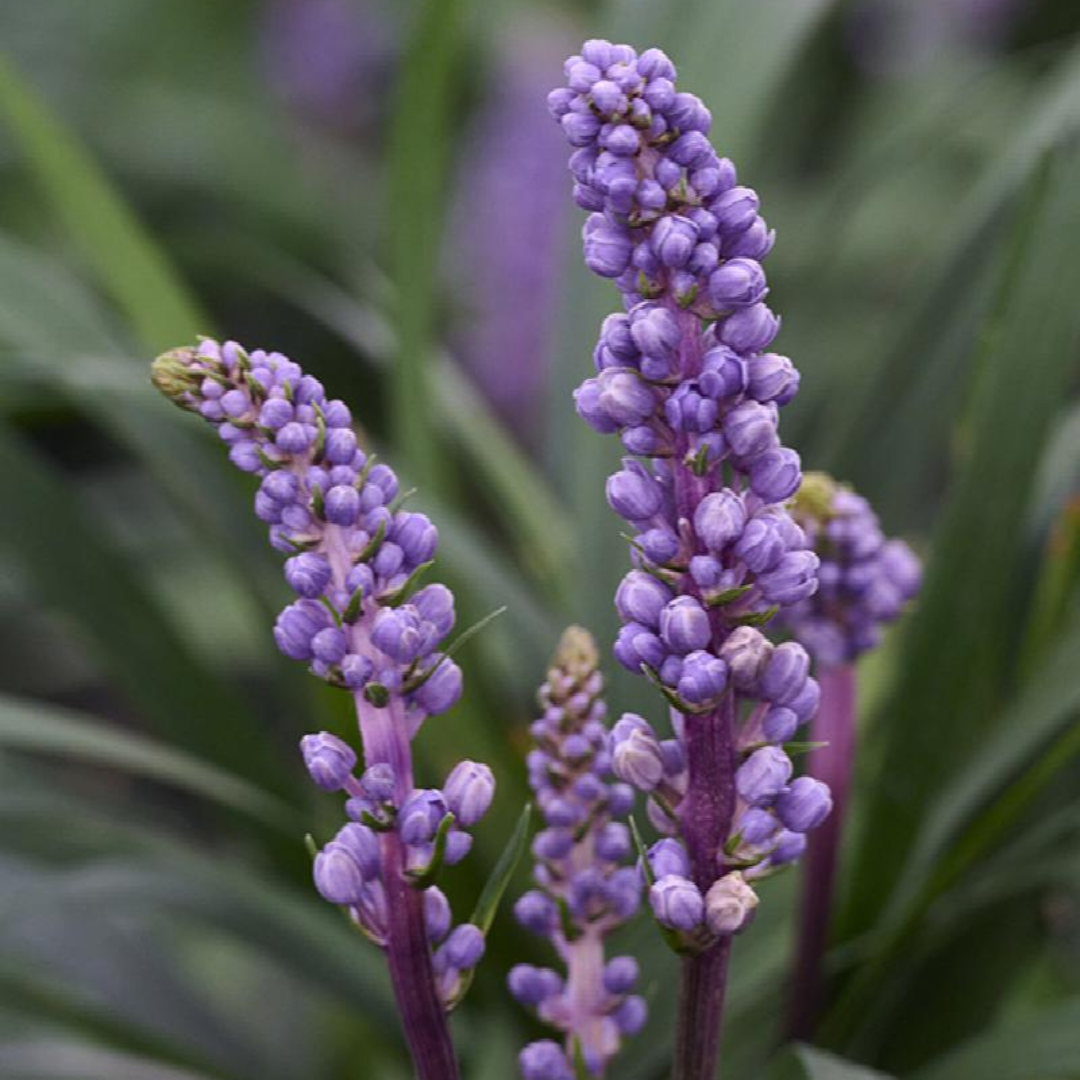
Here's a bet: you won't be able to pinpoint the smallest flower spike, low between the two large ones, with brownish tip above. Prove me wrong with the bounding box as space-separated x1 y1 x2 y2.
510 626 645 1080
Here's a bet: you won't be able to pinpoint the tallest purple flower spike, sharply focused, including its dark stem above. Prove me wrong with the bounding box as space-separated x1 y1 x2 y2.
549 41 829 1080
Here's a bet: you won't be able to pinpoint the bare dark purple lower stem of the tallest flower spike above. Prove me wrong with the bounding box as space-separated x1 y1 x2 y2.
673 692 735 1080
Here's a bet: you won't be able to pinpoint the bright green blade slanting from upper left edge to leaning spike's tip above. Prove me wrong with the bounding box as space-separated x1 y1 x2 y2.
0 51 210 354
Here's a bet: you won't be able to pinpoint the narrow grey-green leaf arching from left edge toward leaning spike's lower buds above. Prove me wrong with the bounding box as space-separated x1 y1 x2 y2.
0 694 296 833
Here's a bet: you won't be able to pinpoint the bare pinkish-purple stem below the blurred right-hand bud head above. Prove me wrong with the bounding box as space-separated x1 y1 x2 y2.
787 664 855 1039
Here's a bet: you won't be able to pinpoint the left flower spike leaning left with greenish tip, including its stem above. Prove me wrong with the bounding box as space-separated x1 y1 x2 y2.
152 340 495 1080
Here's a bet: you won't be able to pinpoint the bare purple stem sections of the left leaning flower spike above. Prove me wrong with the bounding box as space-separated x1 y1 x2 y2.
355 693 460 1080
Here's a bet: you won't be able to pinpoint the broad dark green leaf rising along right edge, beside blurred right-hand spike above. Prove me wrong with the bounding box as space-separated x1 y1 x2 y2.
852 141 1080 937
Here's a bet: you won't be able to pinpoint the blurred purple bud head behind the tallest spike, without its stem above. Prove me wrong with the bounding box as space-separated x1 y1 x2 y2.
784 473 922 669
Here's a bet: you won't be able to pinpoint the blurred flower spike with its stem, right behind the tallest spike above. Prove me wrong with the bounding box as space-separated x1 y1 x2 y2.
784 473 921 1039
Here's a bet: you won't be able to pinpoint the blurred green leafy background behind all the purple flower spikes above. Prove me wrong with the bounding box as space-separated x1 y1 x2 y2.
0 0 1080 1080
